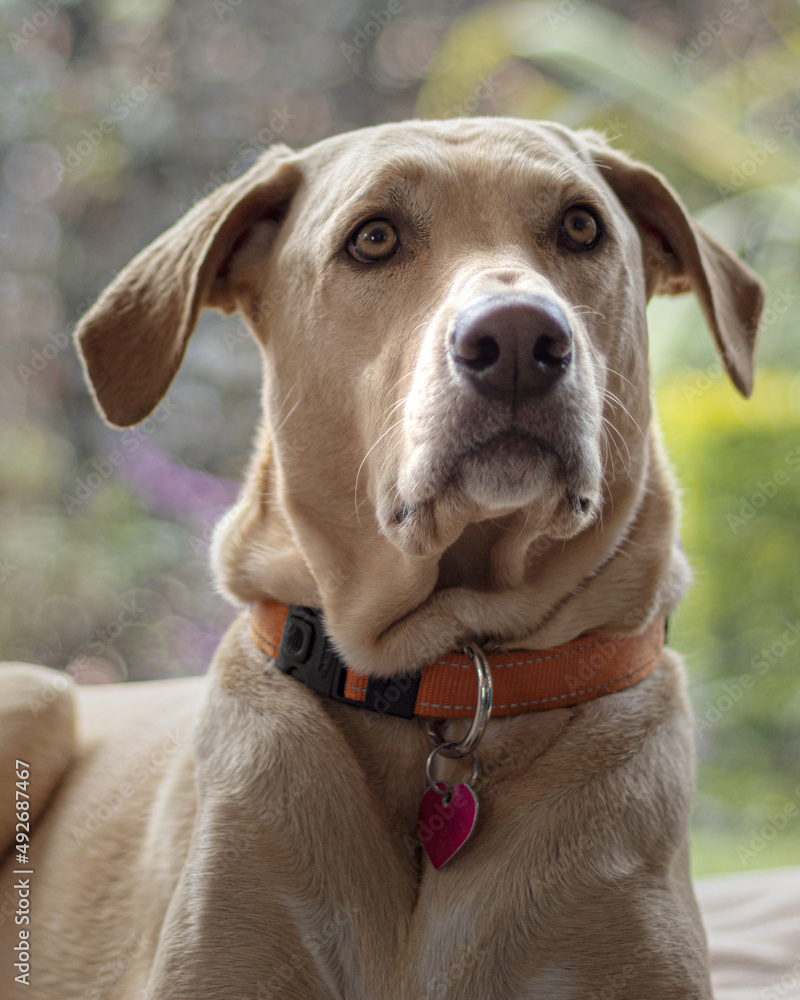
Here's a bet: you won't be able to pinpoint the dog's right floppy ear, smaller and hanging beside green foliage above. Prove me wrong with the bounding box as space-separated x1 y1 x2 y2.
591 146 764 396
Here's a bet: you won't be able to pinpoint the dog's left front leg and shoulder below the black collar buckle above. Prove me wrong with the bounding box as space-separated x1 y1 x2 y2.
145 626 413 1000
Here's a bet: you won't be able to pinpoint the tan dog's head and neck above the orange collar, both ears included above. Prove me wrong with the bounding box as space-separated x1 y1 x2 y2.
78 119 762 673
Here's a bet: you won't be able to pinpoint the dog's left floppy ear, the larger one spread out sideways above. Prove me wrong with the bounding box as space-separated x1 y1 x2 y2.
75 147 300 427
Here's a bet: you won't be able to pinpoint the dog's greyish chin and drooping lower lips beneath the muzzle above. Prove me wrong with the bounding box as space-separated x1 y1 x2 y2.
379 434 600 555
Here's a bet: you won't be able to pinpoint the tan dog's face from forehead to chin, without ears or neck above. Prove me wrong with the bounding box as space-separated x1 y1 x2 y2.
262 121 648 553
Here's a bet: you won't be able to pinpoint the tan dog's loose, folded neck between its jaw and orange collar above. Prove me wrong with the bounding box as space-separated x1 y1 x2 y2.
215 429 688 674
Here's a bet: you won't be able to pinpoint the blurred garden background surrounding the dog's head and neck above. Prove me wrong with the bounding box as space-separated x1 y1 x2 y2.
0 0 800 872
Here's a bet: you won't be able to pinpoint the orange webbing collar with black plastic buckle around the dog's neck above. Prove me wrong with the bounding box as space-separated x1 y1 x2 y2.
250 600 666 719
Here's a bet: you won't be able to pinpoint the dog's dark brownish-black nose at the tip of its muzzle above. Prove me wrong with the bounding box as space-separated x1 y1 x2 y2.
450 294 572 405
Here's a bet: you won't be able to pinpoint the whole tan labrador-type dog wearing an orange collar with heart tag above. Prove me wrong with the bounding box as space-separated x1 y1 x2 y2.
0 119 762 1000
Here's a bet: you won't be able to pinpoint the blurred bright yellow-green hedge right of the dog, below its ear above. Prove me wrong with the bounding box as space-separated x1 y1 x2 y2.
658 369 800 871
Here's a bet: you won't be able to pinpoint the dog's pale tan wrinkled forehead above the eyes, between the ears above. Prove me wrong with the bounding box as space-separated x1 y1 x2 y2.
296 119 603 221
